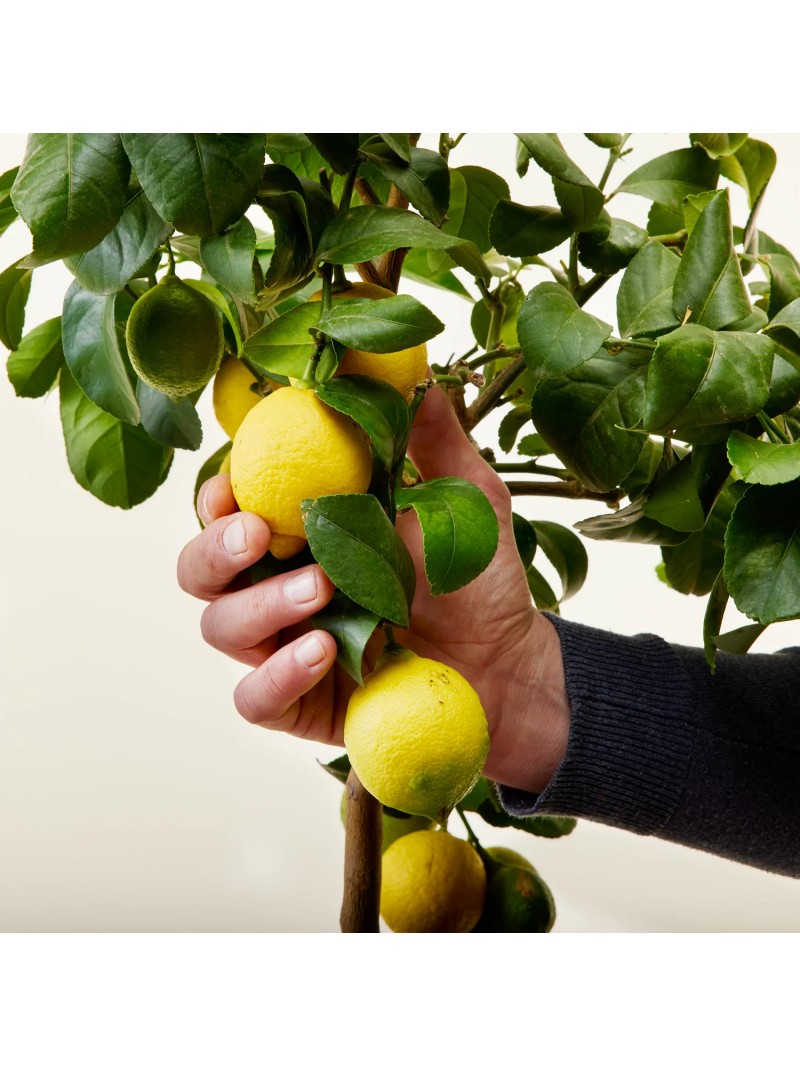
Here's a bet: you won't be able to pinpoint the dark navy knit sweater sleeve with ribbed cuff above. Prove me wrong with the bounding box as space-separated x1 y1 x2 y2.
499 616 800 877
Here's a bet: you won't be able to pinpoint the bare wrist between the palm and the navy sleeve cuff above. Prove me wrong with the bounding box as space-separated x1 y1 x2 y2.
485 611 570 793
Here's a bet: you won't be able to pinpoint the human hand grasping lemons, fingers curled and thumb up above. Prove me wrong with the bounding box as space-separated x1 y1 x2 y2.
178 389 570 792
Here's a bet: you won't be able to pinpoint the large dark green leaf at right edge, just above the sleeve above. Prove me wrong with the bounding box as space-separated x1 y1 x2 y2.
724 478 800 624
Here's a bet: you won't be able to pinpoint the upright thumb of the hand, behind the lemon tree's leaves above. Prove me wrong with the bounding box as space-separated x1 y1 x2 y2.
409 385 500 488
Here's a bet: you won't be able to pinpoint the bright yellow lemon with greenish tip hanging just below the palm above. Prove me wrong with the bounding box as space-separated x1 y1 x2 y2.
345 649 489 825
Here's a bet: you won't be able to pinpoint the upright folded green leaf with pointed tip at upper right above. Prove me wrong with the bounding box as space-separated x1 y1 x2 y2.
672 189 751 330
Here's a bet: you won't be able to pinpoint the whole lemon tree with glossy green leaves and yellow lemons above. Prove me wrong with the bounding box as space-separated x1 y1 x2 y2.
0 133 800 931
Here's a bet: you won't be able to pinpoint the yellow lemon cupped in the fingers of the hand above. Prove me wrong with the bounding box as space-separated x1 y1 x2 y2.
230 387 372 559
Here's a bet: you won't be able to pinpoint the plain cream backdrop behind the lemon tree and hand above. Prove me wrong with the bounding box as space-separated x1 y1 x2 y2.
0 134 800 933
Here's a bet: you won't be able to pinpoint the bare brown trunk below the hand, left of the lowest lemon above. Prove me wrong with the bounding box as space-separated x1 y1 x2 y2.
339 768 383 934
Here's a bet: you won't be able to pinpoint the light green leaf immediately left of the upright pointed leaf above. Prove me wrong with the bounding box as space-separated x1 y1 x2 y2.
617 241 681 337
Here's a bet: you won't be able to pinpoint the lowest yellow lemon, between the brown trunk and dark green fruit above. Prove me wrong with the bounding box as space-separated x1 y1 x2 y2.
381 830 486 934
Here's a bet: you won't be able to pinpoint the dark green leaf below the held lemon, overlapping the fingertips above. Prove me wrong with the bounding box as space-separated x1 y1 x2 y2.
302 494 415 626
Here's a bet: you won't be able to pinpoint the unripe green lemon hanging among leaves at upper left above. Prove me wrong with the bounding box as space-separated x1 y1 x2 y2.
125 274 224 400
